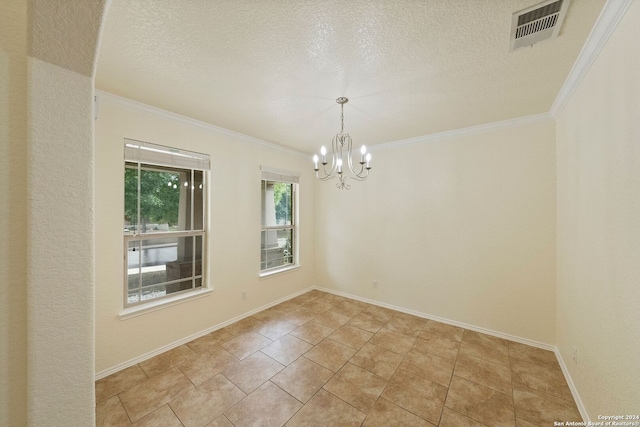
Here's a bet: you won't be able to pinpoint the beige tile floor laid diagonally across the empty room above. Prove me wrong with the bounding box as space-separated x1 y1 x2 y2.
96 290 582 427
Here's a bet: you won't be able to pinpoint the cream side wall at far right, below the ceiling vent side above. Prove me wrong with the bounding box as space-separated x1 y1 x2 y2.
557 1 640 421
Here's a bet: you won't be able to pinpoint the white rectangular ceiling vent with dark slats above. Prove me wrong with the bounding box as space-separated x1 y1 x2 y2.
509 0 570 52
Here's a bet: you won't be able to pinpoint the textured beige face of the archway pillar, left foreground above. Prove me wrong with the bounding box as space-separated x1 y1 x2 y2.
27 59 94 426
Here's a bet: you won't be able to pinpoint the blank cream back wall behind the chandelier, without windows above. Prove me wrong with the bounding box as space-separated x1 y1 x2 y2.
316 118 556 344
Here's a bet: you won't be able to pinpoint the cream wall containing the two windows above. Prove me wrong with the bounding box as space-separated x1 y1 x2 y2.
95 95 317 375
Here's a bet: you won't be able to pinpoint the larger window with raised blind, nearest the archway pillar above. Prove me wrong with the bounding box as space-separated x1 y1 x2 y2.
124 139 210 307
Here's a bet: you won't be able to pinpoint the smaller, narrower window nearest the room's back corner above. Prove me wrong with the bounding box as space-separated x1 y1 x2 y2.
260 166 298 275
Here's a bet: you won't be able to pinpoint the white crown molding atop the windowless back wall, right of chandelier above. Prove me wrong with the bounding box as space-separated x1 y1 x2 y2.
371 113 554 151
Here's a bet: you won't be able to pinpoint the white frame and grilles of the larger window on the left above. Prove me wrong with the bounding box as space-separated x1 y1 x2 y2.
123 138 210 312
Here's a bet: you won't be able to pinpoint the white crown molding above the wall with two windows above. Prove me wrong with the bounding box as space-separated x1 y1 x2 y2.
95 89 309 158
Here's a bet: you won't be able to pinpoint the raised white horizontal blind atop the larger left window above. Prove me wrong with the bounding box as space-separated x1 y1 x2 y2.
124 138 211 170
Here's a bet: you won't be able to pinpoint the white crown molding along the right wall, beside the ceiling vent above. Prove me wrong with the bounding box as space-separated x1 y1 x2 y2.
549 0 633 118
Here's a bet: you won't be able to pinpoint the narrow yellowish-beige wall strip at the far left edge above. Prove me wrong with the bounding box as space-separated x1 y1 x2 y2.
0 1 27 426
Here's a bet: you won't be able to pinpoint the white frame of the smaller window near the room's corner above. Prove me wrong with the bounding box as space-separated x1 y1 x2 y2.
259 166 300 277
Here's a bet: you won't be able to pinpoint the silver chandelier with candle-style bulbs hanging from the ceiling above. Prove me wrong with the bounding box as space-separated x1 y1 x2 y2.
313 96 371 190
